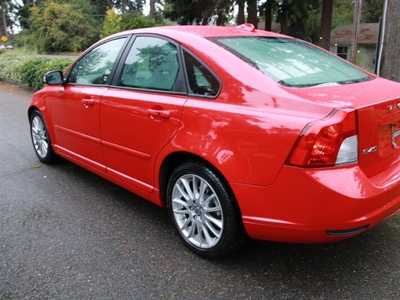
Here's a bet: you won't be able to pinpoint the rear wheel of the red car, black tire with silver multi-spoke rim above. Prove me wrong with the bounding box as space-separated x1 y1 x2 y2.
166 161 244 259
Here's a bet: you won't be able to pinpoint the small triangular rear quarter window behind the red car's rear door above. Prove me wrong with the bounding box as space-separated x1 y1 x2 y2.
184 51 221 96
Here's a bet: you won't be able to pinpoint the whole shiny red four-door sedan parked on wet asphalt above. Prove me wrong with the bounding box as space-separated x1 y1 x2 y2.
28 24 400 258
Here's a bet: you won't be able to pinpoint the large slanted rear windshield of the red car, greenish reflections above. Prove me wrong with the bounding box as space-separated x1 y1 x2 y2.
212 37 371 87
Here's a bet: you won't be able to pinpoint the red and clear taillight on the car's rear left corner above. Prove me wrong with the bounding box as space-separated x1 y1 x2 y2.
288 108 358 167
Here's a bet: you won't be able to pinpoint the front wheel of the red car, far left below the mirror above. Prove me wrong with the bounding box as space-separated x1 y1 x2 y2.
29 110 57 164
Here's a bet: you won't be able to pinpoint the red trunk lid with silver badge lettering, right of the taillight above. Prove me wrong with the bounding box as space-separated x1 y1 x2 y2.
288 78 400 177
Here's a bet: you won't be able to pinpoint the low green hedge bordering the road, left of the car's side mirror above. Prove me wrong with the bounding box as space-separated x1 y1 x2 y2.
0 50 72 90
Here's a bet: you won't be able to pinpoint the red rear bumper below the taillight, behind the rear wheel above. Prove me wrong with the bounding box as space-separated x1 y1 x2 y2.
231 165 400 243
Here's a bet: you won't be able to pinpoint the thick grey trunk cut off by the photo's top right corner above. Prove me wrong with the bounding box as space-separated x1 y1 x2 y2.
380 0 400 82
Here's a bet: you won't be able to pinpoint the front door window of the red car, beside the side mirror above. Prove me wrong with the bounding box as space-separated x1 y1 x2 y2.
68 38 126 85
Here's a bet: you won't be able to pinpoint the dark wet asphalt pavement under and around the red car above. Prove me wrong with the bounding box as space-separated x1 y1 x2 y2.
0 83 400 300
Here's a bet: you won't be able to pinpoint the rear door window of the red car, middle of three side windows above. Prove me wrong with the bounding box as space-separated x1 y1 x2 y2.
118 36 179 91
